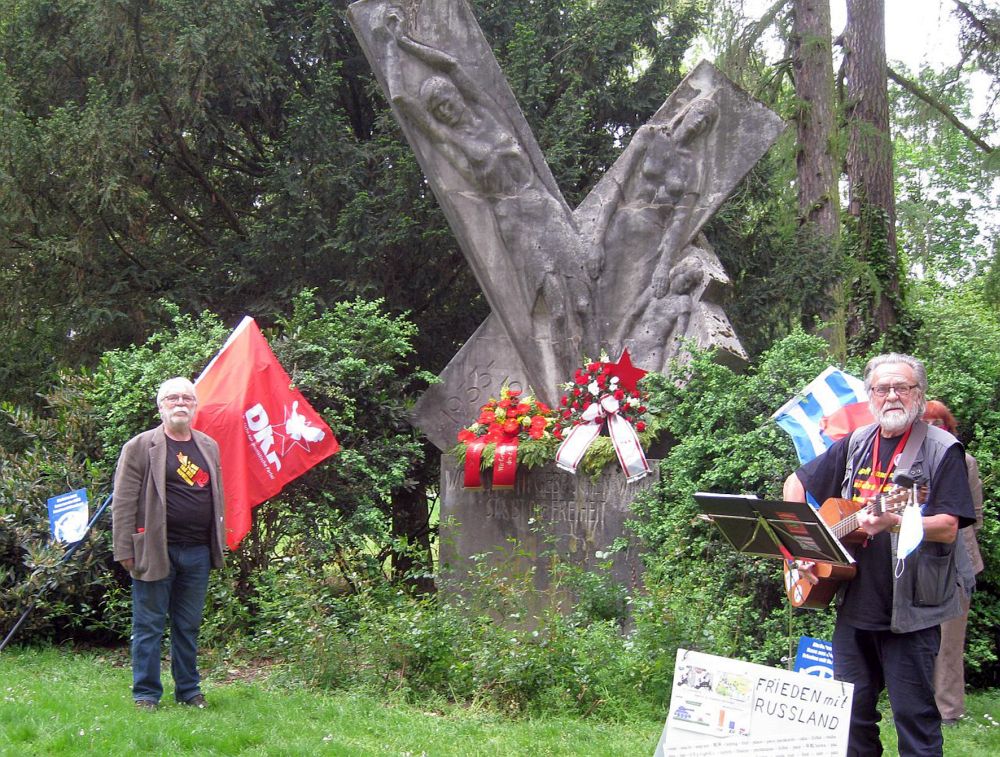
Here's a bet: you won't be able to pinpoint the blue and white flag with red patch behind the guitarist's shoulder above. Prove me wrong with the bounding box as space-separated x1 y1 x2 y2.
771 366 872 464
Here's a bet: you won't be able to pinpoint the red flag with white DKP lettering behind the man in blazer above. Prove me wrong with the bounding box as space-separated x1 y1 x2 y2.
192 316 340 549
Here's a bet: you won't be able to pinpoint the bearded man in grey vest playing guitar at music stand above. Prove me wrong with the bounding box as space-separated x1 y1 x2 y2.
784 353 975 757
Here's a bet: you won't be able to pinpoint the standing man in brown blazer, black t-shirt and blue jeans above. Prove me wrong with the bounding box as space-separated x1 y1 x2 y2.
111 378 225 710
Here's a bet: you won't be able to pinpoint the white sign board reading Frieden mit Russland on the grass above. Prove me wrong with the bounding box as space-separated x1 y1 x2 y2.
655 649 854 757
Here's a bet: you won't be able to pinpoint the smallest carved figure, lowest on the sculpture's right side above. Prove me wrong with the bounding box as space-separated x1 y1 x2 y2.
624 255 705 372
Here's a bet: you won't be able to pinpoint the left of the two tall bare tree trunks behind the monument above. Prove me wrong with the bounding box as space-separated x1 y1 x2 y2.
792 0 846 359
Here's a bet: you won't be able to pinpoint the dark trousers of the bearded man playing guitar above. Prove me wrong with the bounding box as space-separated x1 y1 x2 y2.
833 620 944 757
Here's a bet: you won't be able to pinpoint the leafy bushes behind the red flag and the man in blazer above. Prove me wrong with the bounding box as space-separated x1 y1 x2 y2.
0 292 430 641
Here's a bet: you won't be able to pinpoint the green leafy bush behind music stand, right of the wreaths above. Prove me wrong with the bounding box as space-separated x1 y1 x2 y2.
632 331 860 663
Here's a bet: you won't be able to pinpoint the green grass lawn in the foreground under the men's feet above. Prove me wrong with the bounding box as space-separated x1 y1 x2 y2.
0 648 1000 757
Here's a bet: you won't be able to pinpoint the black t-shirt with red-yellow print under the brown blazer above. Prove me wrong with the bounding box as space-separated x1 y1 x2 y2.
167 437 213 545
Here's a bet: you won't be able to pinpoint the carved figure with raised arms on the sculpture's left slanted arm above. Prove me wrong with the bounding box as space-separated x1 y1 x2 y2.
374 5 593 375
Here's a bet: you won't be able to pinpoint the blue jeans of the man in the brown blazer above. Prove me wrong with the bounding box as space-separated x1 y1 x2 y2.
132 544 212 702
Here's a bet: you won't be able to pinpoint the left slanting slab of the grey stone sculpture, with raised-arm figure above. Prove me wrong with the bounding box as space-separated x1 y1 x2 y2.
349 0 596 399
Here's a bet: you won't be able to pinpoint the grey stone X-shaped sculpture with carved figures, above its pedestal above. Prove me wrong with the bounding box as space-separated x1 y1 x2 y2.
348 0 783 450
